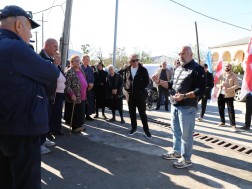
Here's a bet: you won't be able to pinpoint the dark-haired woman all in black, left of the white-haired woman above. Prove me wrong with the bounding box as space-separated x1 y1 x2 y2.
94 62 108 119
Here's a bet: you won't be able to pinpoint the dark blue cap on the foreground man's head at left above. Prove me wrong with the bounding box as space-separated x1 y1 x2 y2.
0 5 40 29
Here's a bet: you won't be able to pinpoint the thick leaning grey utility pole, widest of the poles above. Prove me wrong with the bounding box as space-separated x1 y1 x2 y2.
60 0 73 70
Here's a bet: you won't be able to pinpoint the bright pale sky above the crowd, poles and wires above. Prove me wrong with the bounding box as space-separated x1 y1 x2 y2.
0 0 252 57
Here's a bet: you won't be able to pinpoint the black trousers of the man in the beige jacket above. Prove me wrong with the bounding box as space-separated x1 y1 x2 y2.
218 94 236 126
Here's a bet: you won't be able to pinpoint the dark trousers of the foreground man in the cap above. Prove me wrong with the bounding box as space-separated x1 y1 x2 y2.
0 135 41 189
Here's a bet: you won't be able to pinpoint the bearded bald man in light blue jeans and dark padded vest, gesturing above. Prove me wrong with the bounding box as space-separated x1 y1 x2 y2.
156 46 206 168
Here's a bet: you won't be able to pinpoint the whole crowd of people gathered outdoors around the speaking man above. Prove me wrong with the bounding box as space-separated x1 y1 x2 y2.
0 5 251 189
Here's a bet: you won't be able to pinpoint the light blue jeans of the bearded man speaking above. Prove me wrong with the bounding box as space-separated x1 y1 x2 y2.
171 105 197 160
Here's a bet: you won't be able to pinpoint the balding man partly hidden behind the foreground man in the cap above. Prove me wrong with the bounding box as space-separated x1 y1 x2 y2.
39 38 58 154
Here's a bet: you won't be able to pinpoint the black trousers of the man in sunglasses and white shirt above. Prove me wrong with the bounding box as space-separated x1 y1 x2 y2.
126 94 149 132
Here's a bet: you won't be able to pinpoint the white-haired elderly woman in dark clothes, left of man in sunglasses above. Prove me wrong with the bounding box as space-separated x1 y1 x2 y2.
107 65 125 123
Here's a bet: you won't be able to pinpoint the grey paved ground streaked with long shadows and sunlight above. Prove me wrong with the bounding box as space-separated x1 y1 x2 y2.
42 100 252 189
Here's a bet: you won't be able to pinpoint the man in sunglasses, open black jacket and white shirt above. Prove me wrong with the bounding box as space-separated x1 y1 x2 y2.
124 54 151 138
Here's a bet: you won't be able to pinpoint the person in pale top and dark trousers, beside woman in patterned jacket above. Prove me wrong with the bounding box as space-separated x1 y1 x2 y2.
51 52 66 136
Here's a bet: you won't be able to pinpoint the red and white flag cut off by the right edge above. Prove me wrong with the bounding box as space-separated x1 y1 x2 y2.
240 37 252 99
